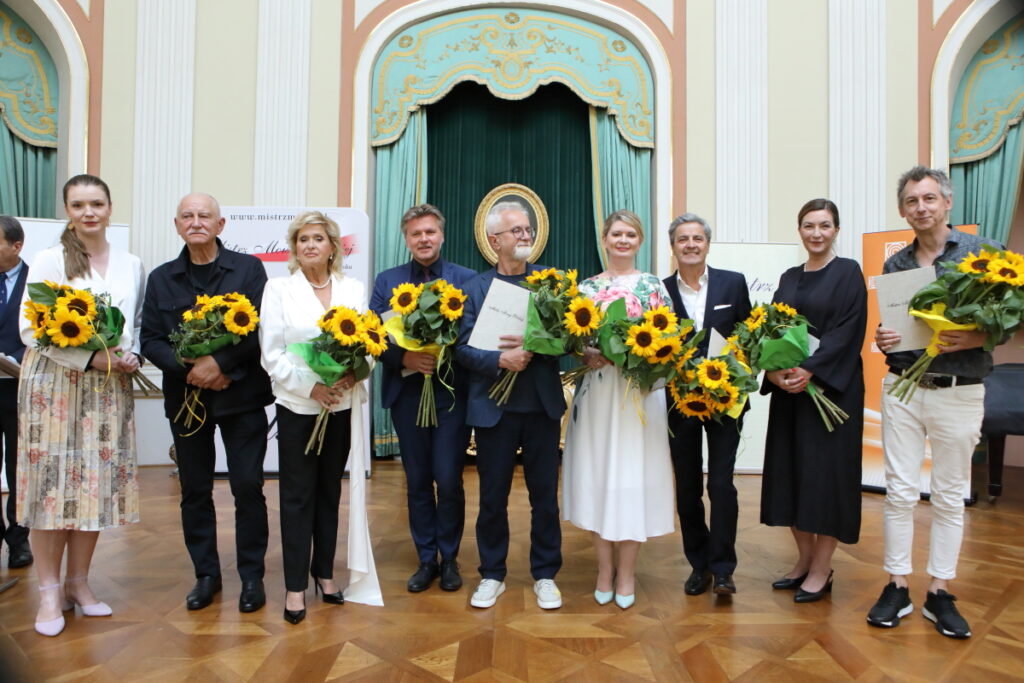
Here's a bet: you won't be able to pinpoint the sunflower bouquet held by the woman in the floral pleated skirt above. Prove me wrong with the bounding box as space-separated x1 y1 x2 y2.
25 280 160 395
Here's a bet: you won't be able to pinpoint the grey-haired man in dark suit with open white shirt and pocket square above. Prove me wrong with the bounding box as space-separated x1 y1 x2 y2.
664 213 751 595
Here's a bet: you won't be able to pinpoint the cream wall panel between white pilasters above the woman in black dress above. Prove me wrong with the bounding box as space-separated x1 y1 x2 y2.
766 0 827 242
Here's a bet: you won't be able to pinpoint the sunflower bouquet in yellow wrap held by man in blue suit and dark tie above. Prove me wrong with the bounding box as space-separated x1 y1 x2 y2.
384 279 466 427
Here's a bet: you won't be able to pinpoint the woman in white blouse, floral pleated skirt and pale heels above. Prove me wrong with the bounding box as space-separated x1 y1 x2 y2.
17 175 145 636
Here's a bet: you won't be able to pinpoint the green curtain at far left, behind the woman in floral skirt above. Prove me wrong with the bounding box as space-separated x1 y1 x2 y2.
0 121 57 218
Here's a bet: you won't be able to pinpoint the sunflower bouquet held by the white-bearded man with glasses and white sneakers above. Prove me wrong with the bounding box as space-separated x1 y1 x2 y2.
487 268 603 405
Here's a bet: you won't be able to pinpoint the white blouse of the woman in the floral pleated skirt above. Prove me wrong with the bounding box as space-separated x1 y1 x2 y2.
18 245 145 370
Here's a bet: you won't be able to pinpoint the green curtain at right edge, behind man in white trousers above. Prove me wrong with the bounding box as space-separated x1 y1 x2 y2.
950 124 1022 245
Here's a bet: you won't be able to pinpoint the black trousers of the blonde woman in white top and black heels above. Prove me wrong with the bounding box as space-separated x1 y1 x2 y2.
276 404 351 591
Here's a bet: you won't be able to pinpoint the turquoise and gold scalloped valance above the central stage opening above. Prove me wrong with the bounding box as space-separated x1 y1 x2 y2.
371 8 654 147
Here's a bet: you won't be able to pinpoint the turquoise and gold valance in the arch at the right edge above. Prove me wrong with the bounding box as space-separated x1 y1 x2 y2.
949 15 1024 164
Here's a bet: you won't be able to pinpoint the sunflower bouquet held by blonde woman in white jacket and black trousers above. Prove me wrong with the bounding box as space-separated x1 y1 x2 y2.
288 306 387 456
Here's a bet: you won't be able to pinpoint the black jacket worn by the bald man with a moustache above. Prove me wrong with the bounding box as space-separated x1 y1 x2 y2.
140 239 273 420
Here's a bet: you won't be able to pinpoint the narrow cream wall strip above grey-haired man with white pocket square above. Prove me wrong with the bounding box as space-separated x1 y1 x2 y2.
674 0 716 228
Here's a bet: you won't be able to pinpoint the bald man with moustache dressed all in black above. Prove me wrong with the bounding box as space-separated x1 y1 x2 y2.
141 193 273 612
